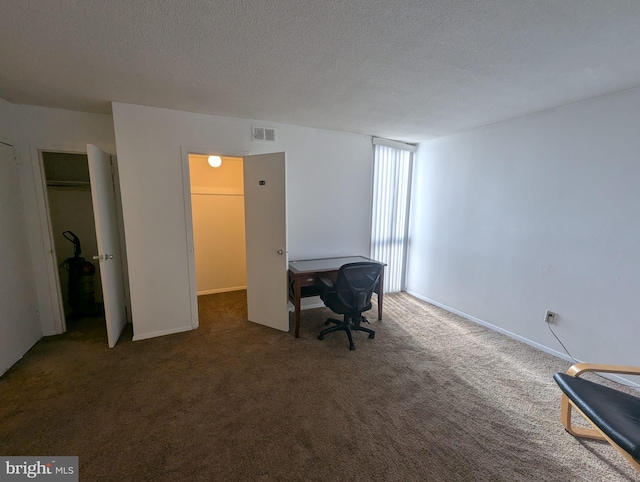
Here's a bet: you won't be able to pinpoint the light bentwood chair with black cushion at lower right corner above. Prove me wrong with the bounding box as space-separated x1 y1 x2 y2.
553 363 640 472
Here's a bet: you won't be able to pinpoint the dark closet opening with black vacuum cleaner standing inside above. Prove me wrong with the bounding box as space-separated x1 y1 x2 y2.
42 152 104 329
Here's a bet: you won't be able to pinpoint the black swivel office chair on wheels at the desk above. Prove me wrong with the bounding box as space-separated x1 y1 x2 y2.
318 262 383 350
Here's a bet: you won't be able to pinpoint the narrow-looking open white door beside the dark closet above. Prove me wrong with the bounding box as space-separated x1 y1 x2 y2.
87 144 127 348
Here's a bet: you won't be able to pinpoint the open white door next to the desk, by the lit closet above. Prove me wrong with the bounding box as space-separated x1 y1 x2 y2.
244 152 289 331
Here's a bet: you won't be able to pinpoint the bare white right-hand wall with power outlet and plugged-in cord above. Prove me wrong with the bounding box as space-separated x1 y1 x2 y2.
408 85 640 365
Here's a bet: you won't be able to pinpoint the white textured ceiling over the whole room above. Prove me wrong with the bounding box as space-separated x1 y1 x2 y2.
0 0 640 141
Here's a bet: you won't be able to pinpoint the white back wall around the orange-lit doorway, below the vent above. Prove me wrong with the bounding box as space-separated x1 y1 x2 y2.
112 103 372 339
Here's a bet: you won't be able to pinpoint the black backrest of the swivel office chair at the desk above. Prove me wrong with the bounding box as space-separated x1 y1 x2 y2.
334 262 383 312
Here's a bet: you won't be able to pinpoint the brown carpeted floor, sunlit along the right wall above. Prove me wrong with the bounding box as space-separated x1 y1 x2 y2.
0 292 639 481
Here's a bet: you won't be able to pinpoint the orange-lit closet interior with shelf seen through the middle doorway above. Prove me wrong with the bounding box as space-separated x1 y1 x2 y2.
188 154 247 297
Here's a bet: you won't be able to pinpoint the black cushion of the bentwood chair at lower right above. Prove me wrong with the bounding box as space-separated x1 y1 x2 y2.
553 373 640 460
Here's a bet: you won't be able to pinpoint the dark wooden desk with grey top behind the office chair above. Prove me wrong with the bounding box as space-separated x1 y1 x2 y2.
288 256 386 338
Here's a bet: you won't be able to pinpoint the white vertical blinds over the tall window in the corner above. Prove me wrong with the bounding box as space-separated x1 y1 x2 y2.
371 139 415 292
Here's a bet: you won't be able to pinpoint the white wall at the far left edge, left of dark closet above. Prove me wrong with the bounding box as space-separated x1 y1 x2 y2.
0 99 42 375
